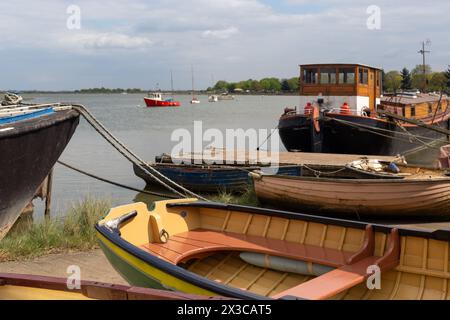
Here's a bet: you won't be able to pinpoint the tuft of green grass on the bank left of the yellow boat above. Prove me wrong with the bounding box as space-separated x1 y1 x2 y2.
0 198 111 261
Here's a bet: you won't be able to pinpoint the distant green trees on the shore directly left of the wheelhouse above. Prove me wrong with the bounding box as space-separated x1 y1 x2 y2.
207 77 298 93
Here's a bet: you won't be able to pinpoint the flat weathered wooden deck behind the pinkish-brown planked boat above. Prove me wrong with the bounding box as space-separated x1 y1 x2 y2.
172 148 395 166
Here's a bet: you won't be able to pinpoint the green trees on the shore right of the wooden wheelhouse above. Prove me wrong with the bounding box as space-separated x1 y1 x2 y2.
383 65 450 92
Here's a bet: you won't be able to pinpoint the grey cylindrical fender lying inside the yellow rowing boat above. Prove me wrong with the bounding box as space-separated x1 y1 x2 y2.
239 252 334 276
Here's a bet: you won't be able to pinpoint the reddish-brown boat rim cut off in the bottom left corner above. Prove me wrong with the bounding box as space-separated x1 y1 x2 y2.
0 273 227 300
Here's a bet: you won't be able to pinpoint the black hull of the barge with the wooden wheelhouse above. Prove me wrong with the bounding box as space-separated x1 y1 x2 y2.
278 114 450 156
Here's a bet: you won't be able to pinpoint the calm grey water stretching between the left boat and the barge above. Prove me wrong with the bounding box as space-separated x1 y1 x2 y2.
24 94 298 217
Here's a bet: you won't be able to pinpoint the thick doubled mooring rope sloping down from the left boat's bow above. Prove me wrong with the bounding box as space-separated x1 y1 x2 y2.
72 105 209 201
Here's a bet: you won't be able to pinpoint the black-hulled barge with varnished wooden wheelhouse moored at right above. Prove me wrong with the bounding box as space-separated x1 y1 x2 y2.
278 64 450 155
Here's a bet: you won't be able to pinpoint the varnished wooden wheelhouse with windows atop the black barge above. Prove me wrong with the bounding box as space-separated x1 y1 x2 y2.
299 64 382 115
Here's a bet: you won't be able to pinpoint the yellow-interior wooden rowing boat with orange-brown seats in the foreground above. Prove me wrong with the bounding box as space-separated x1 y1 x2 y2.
96 199 450 300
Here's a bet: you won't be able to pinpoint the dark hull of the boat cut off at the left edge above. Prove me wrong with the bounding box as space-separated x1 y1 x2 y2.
0 110 79 239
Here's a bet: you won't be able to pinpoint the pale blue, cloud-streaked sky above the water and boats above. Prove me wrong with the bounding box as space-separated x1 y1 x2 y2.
0 0 450 90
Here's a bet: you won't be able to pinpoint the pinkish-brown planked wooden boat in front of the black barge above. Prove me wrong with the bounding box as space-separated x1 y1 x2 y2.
252 166 450 218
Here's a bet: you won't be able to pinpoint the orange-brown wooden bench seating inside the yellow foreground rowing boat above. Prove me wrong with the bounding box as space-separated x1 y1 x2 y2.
141 225 400 299
